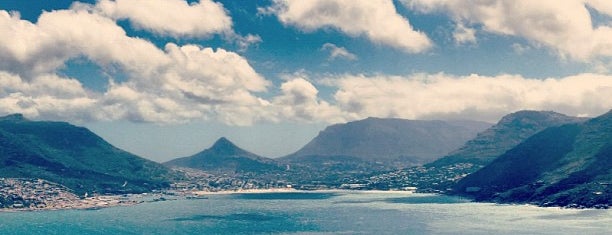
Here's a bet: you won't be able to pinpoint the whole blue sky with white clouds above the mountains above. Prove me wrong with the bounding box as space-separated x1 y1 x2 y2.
0 0 612 161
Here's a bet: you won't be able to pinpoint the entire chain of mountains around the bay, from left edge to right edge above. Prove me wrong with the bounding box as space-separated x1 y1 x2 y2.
0 111 612 208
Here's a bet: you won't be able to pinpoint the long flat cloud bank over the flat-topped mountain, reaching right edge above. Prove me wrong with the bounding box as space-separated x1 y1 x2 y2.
332 74 612 121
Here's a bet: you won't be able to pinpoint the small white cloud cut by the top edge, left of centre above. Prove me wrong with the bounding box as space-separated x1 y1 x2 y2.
95 0 232 37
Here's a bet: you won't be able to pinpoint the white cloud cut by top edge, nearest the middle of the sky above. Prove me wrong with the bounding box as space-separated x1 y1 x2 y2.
260 0 432 53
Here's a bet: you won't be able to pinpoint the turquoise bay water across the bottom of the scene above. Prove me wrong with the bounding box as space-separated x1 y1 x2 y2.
0 192 612 234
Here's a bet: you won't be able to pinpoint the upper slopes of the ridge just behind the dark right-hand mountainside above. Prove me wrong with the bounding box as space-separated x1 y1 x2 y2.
425 110 586 167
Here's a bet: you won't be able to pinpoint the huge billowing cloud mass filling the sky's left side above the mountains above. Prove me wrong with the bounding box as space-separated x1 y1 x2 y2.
0 4 271 125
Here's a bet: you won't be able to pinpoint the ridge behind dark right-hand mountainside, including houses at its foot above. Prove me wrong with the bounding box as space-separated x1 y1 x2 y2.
364 110 587 192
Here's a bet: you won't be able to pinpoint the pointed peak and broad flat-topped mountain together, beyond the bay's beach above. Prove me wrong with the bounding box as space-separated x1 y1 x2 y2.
164 118 491 184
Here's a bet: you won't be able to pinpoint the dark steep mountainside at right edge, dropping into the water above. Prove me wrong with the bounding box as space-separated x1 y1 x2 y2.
454 111 612 208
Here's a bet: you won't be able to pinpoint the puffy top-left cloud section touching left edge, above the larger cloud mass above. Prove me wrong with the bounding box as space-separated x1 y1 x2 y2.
0 10 166 79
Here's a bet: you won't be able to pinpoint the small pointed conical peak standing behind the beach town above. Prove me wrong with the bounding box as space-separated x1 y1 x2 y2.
164 137 283 174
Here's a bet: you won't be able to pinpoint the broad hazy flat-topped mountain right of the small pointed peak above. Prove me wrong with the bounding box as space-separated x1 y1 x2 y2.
282 118 490 167
